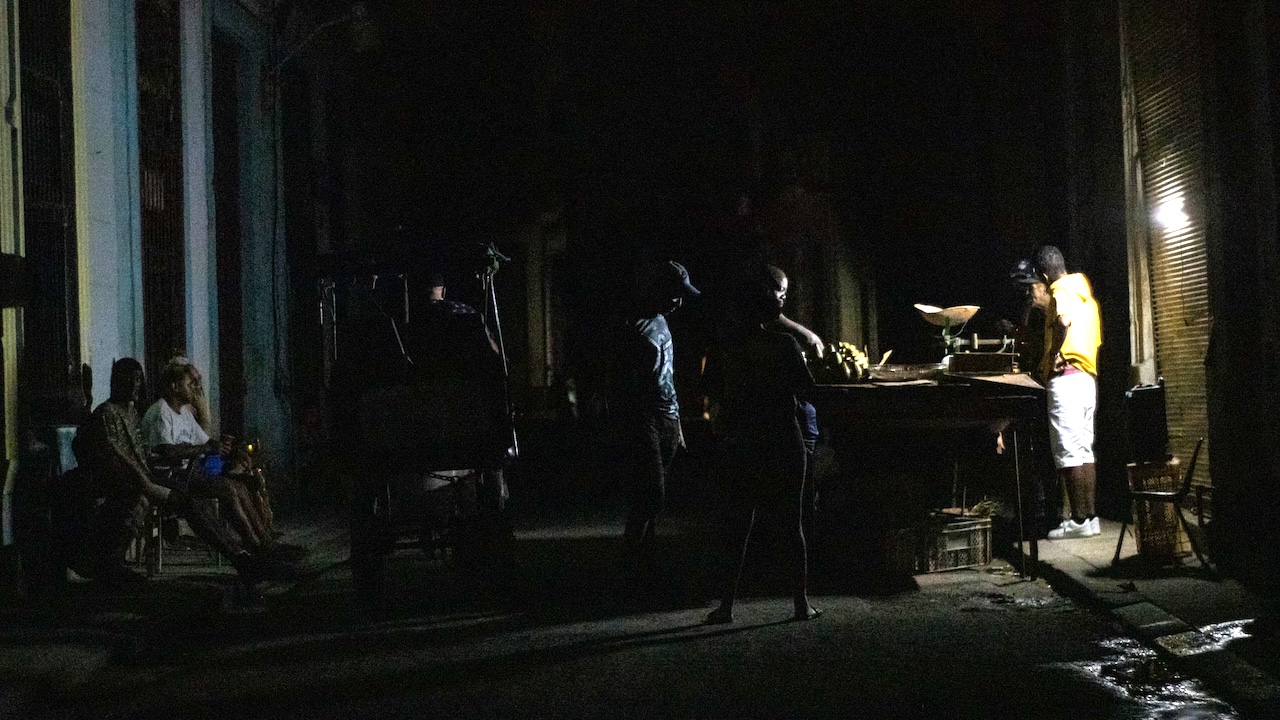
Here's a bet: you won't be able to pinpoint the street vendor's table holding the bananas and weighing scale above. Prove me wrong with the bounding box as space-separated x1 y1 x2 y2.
809 373 1047 578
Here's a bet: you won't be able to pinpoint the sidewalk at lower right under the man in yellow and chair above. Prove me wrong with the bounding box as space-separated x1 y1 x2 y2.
1015 520 1280 717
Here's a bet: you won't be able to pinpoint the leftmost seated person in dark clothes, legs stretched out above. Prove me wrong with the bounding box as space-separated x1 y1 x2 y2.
83 357 264 582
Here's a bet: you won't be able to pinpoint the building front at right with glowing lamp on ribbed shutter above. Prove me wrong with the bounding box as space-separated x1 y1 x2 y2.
1065 0 1280 580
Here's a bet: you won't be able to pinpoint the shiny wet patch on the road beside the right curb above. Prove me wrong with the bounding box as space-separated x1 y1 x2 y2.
1048 638 1239 720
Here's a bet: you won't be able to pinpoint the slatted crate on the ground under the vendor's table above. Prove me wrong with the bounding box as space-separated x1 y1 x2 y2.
890 514 991 575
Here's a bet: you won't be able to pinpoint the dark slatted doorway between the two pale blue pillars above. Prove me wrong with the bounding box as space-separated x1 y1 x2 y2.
134 0 187 389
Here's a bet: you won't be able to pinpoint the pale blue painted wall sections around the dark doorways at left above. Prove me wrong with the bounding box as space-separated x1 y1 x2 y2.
72 0 292 478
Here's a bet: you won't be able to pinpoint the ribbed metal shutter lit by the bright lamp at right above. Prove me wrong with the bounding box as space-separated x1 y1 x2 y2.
1121 0 1211 483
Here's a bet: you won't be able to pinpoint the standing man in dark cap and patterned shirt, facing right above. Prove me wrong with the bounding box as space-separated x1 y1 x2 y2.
609 260 701 565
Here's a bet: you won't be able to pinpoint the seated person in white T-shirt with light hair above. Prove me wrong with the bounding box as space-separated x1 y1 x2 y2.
142 359 271 555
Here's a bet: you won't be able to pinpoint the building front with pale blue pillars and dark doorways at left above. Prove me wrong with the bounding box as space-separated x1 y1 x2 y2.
0 0 348 543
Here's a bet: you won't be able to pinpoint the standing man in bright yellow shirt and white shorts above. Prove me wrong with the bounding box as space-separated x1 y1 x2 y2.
1018 245 1102 539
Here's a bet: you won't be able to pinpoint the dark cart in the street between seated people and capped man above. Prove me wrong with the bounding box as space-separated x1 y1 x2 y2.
320 249 518 603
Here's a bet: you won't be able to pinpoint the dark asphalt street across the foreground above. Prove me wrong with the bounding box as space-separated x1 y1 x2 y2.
5 507 1233 720
